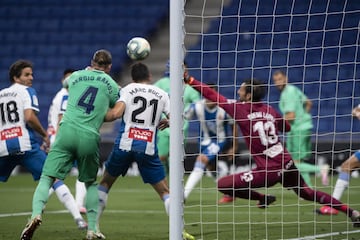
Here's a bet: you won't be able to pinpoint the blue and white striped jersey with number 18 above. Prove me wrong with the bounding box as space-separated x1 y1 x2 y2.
0 83 39 157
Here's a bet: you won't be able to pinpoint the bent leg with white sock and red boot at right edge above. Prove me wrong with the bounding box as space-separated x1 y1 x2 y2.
317 151 360 215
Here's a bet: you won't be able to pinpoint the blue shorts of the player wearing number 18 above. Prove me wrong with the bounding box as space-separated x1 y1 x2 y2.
0 147 46 182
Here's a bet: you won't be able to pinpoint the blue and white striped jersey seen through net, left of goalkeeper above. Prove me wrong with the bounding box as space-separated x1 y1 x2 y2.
185 99 233 146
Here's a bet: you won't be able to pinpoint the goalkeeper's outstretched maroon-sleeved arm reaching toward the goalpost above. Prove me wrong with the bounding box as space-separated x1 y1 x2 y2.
184 75 235 117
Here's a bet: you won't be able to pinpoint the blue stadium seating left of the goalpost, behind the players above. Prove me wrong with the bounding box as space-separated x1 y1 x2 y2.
0 0 169 126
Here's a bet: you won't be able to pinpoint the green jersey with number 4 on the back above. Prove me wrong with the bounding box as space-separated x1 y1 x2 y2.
62 69 119 134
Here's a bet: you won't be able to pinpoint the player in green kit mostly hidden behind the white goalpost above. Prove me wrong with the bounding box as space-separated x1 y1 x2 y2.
154 62 200 172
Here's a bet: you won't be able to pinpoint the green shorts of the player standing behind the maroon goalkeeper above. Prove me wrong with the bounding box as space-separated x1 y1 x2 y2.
286 130 312 161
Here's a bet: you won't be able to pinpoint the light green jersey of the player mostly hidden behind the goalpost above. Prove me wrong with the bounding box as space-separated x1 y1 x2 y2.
154 77 200 111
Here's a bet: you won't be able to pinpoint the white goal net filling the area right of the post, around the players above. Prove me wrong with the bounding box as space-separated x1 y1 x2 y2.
184 0 360 239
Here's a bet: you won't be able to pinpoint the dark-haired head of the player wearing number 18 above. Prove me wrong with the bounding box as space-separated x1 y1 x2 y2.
9 60 33 87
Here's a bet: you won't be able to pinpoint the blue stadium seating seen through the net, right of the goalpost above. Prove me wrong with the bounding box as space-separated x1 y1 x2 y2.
186 0 360 137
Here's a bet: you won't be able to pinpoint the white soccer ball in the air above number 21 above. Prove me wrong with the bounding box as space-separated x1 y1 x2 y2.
126 37 151 60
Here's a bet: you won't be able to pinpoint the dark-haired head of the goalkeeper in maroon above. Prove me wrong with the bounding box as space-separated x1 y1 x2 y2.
238 79 266 102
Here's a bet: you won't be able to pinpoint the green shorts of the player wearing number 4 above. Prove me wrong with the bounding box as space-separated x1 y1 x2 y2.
42 123 100 182
